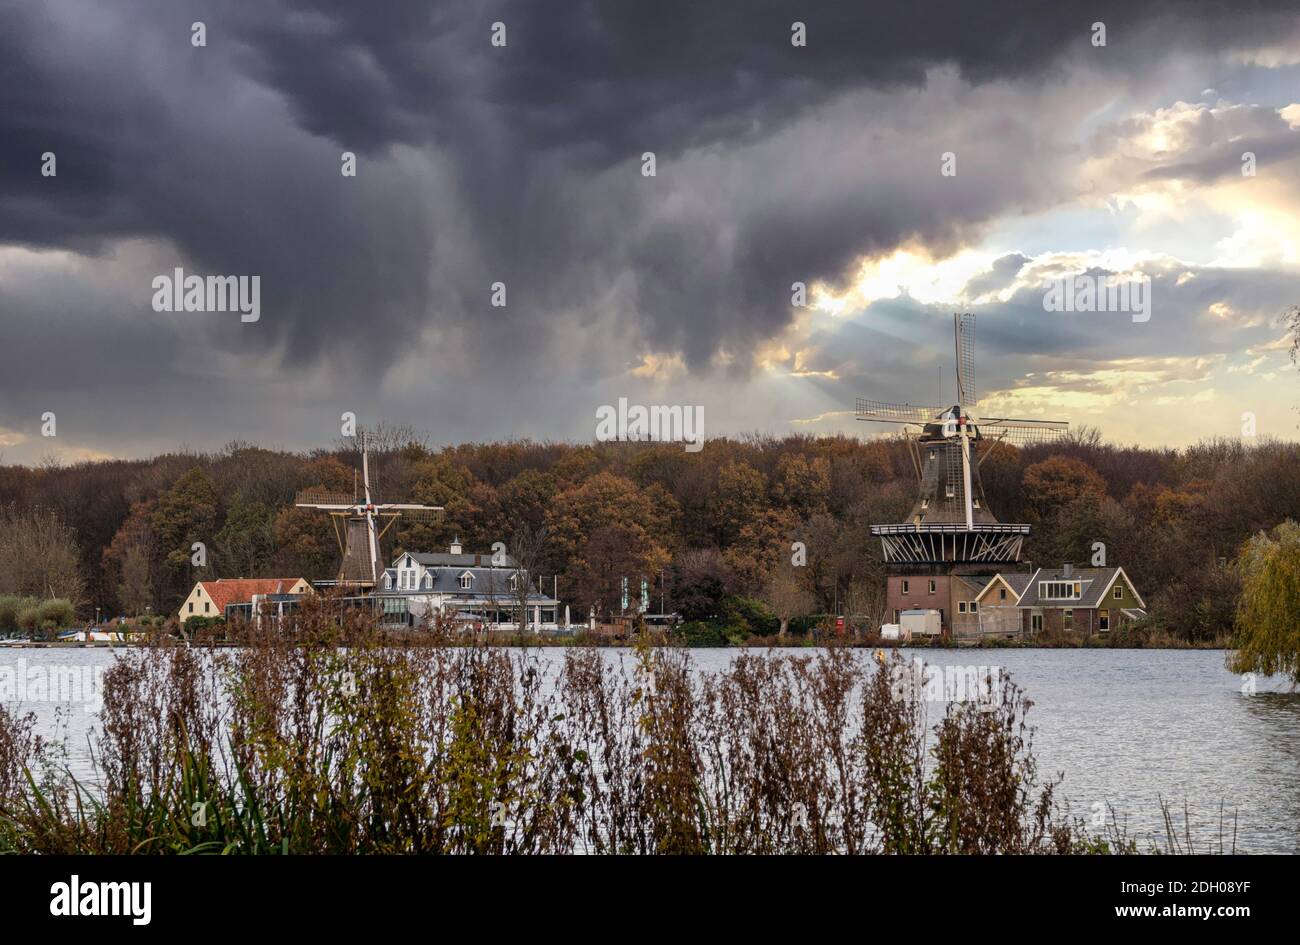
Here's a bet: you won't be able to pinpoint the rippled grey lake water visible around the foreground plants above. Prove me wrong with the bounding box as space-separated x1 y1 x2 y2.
0 649 1300 853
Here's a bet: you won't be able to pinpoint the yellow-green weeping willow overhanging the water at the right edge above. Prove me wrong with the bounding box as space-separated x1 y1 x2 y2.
1230 519 1300 682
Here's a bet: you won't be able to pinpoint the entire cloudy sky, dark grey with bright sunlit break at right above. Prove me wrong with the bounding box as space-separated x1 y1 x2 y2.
0 0 1300 463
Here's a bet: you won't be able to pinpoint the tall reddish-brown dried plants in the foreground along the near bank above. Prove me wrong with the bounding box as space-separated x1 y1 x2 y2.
0 611 1138 854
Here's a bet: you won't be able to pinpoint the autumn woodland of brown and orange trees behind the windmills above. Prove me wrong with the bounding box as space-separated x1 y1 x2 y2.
0 428 1300 641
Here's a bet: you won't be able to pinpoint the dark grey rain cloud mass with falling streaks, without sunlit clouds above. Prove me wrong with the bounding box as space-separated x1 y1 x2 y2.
0 0 1290 457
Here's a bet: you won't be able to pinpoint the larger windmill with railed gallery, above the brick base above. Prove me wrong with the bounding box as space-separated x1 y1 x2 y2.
858 315 1069 565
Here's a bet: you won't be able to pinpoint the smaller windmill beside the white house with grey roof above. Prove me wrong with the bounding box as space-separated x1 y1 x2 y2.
294 433 442 588
